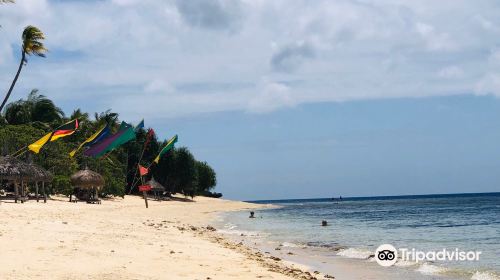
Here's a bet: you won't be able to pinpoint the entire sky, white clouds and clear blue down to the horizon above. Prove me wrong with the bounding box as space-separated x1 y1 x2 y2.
0 0 500 200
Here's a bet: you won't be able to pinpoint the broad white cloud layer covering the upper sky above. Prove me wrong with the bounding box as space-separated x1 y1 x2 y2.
0 0 500 118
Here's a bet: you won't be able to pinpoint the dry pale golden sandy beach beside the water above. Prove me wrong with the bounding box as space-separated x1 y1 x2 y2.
0 196 324 279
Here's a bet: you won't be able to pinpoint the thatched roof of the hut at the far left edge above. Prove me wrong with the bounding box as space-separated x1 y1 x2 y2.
0 156 37 182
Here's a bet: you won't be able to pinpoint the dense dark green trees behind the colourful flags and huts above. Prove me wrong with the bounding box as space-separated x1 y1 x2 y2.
0 90 217 196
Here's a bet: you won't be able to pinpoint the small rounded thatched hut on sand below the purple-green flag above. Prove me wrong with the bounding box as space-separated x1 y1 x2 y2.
69 168 104 204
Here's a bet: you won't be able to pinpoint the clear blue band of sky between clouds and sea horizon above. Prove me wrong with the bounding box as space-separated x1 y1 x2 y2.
175 95 500 199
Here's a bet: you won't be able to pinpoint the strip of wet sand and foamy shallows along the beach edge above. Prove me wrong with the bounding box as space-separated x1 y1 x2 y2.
219 203 498 280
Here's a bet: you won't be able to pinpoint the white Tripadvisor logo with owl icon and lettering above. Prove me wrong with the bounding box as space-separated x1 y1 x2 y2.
375 244 482 266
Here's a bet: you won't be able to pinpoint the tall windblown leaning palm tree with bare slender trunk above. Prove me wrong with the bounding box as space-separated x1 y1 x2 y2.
0 25 47 112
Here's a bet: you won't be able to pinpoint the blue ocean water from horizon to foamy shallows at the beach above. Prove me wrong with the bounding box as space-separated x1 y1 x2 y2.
218 193 500 280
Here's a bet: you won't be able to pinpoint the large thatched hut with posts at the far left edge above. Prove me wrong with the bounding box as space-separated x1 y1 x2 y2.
0 156 52 203
